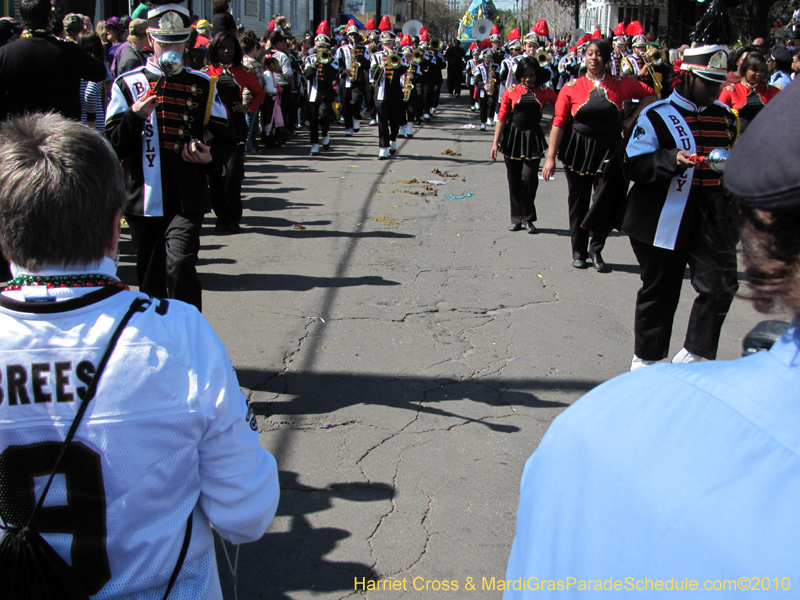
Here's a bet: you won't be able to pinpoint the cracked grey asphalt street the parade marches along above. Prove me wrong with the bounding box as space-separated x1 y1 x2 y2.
120 95 762 600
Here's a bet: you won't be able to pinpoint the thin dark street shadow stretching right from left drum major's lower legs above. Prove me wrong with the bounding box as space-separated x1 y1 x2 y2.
199 273 400 292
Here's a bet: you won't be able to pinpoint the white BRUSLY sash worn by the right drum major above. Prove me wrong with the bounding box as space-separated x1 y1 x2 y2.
652 102 697 250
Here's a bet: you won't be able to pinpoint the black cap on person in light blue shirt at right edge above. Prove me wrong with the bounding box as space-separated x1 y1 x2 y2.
723 77 800 214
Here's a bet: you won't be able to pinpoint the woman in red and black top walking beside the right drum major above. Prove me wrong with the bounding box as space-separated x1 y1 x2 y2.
542 39 656 271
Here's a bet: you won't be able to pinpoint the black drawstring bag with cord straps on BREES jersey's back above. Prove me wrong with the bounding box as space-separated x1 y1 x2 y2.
0 299 192 600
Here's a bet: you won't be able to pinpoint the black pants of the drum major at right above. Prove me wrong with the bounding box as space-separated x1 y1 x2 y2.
631 227 738 360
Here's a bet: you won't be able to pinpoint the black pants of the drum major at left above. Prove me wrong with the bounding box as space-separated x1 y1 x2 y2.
125 215 203 310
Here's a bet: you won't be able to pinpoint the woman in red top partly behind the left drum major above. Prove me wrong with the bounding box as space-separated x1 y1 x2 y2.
206 31 264 233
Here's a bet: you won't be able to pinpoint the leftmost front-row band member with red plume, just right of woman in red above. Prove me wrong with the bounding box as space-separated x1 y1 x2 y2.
303 28 339 156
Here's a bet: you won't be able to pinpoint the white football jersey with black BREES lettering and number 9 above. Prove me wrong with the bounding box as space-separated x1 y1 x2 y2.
0 288 279 600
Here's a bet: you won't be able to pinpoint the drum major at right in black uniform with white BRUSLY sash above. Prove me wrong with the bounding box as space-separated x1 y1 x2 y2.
621 45 738 371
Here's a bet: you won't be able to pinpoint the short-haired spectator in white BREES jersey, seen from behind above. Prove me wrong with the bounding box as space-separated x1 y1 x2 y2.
0 114 279 600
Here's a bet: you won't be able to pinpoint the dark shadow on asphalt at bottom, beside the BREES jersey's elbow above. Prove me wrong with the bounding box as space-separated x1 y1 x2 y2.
214 471 395 600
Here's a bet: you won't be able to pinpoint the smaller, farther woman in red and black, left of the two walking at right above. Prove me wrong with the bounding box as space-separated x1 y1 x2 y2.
491 56 556 233
